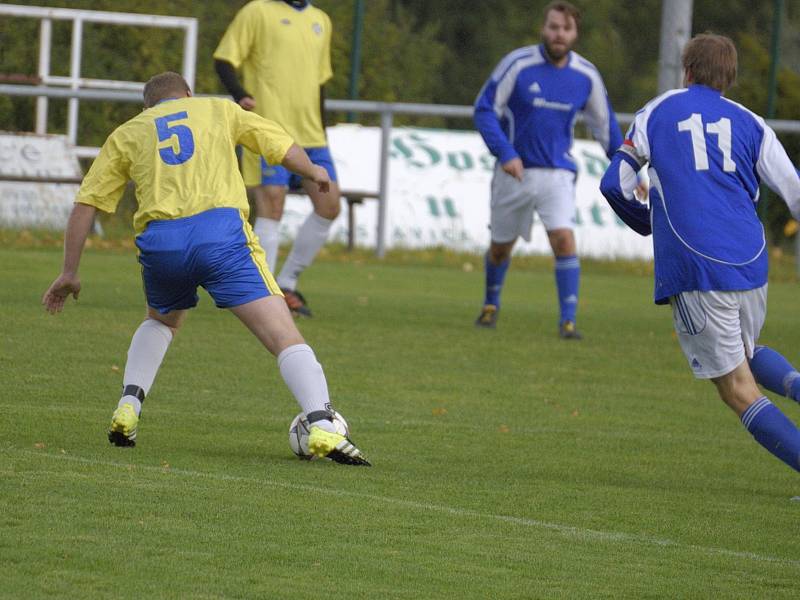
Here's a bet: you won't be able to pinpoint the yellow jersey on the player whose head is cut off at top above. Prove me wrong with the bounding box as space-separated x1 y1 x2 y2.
214 0 333 148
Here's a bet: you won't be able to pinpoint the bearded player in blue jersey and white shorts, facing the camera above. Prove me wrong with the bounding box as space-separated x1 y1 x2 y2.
475 1 622 339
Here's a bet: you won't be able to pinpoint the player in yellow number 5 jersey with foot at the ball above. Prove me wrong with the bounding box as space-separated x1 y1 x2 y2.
42 73 369 465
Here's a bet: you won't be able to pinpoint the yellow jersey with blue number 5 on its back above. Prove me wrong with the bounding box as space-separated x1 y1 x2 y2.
75 98 294 234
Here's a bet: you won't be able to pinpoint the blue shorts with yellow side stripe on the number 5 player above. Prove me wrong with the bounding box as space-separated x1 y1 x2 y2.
136 208 281 314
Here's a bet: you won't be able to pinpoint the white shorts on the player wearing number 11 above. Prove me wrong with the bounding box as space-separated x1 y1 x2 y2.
669 285 767 379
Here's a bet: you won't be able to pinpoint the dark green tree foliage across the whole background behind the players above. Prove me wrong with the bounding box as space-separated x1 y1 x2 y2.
0 0 800 239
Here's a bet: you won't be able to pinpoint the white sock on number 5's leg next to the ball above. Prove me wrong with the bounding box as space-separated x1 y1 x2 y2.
278 344 335 431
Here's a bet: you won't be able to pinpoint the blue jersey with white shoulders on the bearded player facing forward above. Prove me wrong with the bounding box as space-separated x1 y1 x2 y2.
475 45 622 172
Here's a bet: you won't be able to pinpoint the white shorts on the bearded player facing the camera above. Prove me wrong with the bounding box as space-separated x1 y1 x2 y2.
491 164 575 243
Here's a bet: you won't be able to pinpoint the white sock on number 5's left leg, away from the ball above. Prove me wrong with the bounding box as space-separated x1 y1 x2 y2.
119 318 172 415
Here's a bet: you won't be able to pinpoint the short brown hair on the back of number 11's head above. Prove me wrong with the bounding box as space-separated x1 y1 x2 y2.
681 33 738 92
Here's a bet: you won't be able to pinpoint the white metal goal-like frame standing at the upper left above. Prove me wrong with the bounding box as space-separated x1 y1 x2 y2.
0 4 197 157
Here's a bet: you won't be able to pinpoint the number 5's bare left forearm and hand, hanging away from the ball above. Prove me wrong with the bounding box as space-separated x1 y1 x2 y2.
42 204 97 314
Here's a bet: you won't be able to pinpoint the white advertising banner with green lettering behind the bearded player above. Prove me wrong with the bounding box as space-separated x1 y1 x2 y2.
282 124 653 259
